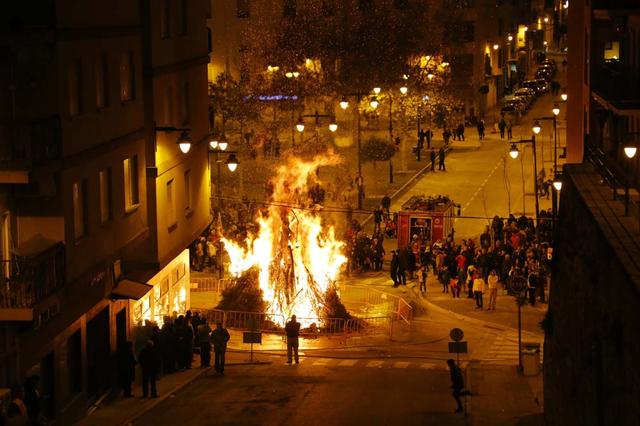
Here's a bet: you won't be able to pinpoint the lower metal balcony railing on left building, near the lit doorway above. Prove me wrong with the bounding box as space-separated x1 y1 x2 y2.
0 243 65 309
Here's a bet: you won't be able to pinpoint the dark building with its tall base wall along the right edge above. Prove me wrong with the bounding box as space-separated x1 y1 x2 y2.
544 0 640 425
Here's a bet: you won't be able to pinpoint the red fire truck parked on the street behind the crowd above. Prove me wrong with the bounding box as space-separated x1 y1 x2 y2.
397 195 460 248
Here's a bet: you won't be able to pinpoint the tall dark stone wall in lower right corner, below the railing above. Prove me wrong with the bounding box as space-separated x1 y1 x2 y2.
544 164 640 426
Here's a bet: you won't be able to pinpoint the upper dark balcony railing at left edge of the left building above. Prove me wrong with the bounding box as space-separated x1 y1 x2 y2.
0 116 62 168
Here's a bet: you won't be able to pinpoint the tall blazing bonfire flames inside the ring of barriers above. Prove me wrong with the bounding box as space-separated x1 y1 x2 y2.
222 154 347 325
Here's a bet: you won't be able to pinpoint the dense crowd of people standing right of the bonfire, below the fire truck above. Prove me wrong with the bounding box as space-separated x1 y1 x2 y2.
380 211 552 310
